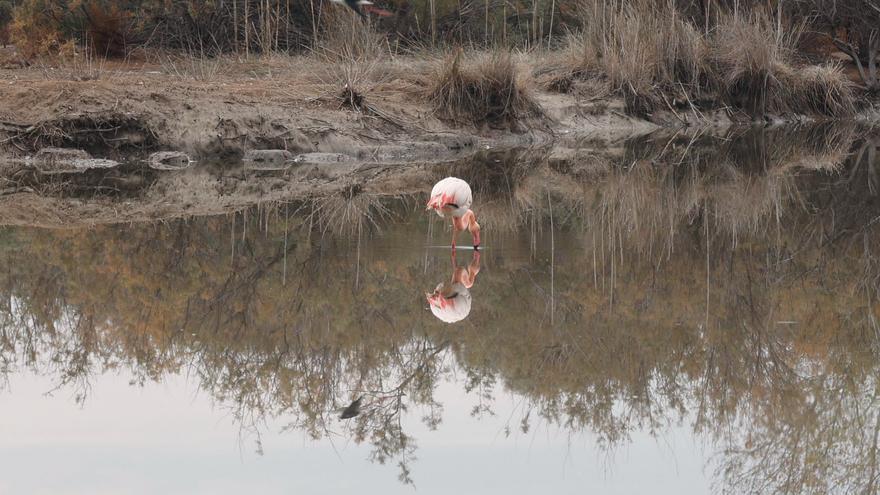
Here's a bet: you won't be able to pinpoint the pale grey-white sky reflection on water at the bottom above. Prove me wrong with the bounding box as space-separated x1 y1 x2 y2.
0 373 708 495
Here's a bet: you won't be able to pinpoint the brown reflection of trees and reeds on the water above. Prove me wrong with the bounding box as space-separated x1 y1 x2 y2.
0 129 880 493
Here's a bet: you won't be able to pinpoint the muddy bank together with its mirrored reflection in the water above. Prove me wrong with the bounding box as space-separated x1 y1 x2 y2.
0 60 875 227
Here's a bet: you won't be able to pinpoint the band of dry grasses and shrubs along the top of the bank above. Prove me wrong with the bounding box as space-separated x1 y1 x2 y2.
0 0 876 134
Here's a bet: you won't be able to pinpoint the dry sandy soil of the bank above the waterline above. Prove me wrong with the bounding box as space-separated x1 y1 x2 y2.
0 53 668 156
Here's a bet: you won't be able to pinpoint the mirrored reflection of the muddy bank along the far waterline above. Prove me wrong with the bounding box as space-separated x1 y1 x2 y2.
0 126 880 228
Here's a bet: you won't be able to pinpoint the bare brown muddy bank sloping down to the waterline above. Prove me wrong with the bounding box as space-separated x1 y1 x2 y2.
0 60 657 162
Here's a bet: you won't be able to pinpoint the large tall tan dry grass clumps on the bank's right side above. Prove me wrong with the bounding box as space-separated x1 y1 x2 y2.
547 0 854 117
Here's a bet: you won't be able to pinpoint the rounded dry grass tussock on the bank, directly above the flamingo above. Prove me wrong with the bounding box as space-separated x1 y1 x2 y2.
428 50 539 125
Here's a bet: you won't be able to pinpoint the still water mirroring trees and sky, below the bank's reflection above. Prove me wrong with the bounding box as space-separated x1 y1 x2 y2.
0 129 880 494
